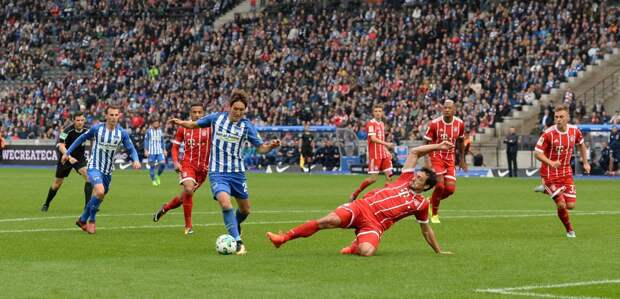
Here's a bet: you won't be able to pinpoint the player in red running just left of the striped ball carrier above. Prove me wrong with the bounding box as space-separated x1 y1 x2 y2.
153 103 211 235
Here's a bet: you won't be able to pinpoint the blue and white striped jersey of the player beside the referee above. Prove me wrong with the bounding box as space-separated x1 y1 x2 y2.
67 123 138 175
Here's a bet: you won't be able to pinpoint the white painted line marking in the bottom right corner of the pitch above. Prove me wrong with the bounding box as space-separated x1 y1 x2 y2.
475 279 620 299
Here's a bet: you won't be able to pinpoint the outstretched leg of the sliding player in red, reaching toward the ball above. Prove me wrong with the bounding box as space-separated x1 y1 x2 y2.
267 210 344 248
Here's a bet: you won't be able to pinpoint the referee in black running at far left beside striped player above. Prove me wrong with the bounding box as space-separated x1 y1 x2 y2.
41 112 93 212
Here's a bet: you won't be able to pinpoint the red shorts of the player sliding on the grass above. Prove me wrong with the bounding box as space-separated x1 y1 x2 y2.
334 201 383 249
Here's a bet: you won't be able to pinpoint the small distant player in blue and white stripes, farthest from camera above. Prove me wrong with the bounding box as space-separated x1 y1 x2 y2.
144 119 167 186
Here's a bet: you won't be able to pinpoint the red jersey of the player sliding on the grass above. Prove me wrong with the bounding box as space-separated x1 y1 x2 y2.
360 170 429 231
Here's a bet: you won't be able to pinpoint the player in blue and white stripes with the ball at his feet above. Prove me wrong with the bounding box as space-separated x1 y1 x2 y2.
170 92 280 255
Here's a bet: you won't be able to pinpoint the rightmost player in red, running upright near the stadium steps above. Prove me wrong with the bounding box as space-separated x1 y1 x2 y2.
535 105 590 238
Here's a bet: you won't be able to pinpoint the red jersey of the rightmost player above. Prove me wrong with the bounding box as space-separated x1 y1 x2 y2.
536 125 584 180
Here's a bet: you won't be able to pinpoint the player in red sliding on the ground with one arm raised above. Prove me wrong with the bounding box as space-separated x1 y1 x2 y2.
267 141 452 256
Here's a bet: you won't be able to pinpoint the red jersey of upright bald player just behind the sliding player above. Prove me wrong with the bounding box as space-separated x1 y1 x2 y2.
424 116 465 163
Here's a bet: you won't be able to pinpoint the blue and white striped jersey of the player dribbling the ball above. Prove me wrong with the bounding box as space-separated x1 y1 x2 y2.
197 112 263 173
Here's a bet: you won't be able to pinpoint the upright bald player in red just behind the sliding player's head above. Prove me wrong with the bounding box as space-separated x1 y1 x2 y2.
424 100 467 223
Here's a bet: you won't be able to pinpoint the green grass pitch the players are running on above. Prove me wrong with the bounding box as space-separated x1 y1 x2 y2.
0 168 620 298
